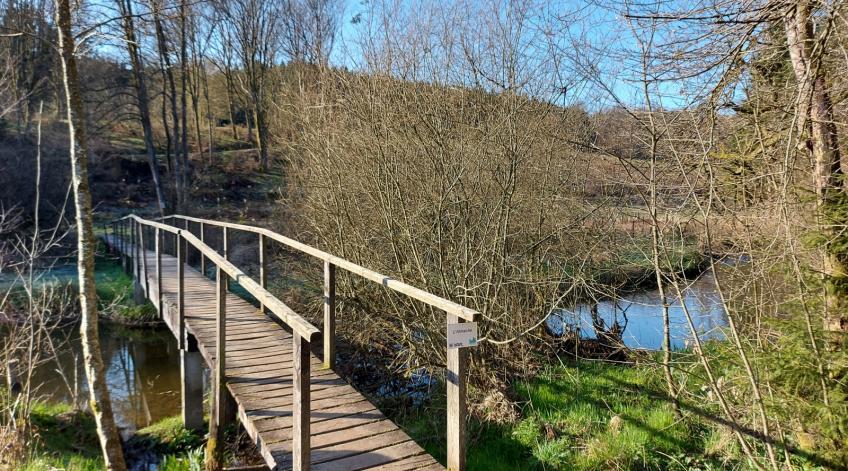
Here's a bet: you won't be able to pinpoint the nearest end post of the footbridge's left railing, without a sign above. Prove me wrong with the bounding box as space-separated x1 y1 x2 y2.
292 333 311 471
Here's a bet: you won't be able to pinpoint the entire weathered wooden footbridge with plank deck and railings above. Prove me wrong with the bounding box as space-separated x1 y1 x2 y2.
104 215 477 470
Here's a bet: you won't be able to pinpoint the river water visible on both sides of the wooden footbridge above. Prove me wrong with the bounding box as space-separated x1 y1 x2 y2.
6 262 727 435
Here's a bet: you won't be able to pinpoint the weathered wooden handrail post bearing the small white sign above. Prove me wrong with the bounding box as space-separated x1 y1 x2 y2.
445 314 468 471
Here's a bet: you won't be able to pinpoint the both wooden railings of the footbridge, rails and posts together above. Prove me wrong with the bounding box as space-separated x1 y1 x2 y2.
103 215 479 470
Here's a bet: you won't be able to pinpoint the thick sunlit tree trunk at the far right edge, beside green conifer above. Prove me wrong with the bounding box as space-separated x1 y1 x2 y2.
785 1 848 345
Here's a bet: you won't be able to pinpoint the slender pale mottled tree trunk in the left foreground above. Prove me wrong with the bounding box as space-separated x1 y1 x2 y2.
55 0 127 471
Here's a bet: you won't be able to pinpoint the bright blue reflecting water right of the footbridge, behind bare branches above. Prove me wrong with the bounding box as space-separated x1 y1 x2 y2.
547 272 727 350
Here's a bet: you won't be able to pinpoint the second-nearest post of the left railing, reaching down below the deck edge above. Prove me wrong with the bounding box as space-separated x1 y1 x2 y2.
206 266 229 469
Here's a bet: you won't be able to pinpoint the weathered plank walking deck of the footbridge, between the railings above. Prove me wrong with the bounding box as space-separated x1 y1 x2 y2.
105 235 445 471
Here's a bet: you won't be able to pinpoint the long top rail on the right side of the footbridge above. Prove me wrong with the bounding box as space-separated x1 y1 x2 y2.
160 214 480 322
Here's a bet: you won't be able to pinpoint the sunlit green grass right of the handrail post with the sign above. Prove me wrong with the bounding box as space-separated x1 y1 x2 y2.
401 362 720 470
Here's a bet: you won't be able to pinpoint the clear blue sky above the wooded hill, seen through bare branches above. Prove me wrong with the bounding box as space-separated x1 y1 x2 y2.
324 0 744 109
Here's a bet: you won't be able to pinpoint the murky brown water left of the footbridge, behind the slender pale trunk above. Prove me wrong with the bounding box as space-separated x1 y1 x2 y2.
33 324 190 433
